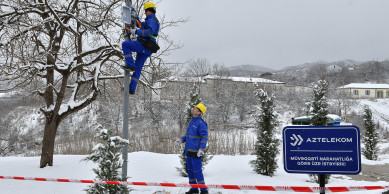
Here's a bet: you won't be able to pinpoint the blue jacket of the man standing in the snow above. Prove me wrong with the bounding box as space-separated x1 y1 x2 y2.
182 116 208 156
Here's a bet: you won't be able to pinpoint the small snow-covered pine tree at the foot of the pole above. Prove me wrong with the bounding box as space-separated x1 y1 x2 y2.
84 129 129 194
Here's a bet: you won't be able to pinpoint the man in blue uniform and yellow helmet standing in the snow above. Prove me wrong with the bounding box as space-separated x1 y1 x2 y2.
176 103 208 194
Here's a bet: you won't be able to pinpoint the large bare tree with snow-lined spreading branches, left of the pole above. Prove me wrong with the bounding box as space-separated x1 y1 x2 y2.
0 0 187 168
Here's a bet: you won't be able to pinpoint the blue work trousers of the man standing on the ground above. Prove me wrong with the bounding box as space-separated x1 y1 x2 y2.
186 156 207 191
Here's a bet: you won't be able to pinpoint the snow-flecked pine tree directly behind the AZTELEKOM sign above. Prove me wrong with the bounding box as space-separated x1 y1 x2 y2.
309 80 331 184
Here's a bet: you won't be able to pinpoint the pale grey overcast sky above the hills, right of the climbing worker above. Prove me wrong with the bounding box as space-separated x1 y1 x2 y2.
157 0 389 69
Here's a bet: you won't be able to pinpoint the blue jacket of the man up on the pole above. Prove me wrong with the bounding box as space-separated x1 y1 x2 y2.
136 14 159 42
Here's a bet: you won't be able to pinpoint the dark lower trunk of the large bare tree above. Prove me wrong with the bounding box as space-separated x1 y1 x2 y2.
40 119 58 168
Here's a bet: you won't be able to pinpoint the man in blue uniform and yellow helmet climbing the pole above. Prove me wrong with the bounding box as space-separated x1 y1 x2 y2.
122 2 160 94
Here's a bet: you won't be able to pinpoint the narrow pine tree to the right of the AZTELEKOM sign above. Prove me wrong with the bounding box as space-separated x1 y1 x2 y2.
362 106 379 160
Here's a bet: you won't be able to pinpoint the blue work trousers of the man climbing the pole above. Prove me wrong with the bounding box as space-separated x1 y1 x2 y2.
122 41 151 92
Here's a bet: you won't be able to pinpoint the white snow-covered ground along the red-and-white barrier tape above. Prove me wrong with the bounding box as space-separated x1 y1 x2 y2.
0 152 389 194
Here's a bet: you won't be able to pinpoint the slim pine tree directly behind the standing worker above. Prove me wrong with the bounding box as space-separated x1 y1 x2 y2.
176 83 213 177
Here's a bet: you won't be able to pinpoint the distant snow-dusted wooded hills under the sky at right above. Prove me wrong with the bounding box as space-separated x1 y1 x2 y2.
273 60 389 88
